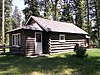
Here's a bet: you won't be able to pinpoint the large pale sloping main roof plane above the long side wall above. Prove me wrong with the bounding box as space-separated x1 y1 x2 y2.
31 16 88 34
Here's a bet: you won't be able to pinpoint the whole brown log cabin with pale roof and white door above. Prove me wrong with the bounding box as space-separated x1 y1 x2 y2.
7 16 88 56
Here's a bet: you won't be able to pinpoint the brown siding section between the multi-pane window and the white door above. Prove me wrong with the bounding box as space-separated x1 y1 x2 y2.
21 30 35 55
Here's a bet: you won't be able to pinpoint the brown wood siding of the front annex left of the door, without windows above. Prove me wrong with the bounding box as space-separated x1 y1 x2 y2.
10 30 35 55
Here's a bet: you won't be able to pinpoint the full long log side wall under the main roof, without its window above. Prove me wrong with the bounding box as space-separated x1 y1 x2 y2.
50 33 86 51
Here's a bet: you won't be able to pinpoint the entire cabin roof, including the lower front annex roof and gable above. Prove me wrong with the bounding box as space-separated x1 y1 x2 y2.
9 16 88 34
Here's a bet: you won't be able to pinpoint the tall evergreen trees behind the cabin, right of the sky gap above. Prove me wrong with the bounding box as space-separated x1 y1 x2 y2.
23 0 100 46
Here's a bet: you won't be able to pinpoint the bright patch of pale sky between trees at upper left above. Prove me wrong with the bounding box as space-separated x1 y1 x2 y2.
12 0 25 17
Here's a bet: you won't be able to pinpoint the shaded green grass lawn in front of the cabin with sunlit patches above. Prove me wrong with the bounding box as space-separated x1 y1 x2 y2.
0 49 100 75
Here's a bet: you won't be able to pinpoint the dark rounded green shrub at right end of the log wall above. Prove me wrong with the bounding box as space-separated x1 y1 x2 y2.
74 46 86 57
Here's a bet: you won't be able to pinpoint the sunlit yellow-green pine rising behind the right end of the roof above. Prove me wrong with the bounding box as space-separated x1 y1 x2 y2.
74 0 86 29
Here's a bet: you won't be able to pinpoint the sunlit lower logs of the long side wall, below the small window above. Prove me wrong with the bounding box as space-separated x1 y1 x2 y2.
51 39 85 50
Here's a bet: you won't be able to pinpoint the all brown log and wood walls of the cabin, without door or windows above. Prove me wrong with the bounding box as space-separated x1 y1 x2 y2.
10 30 86 56
